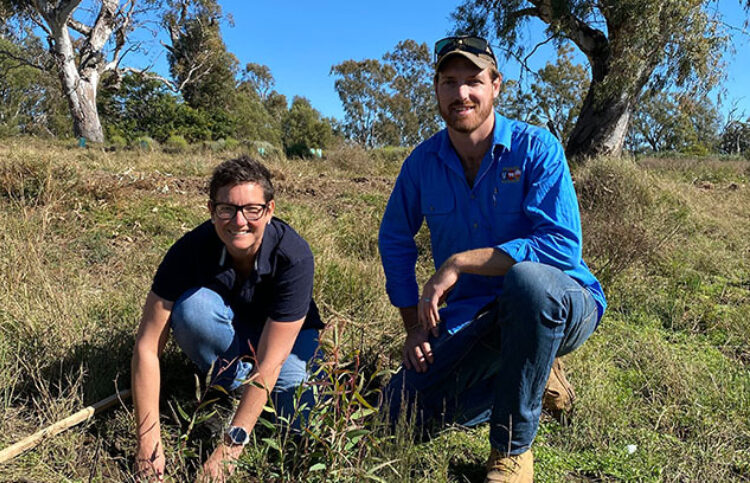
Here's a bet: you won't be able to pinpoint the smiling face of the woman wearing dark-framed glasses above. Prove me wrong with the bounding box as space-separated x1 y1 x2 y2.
208 183 276 260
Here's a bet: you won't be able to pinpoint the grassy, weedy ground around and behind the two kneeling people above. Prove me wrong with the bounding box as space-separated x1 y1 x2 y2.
0 140 750 481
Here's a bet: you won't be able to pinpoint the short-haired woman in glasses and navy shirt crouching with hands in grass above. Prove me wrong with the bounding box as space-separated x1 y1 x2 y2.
132 156 323 480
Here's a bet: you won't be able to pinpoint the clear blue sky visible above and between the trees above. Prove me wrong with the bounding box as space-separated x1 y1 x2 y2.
130 0 750 119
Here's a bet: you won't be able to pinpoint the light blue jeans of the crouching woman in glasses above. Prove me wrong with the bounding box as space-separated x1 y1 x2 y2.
170 287 318 424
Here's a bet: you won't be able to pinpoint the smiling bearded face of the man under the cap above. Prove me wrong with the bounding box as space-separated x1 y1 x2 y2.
435 55 500 133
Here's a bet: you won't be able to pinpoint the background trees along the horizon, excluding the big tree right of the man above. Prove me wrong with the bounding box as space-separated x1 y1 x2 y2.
0 0 750 156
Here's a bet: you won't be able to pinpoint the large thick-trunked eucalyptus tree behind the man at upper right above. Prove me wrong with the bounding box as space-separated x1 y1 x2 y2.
452 0 750 158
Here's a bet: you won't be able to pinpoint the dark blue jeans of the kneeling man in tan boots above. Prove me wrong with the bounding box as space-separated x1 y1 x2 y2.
385 262 598 455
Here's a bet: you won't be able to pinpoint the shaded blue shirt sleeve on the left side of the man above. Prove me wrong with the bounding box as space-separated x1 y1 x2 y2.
378 158 423 307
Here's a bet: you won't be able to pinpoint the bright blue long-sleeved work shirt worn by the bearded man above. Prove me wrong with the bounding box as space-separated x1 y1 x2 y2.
379 114 607 333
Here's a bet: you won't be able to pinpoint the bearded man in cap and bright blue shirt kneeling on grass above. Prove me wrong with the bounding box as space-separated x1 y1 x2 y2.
379 36 606 481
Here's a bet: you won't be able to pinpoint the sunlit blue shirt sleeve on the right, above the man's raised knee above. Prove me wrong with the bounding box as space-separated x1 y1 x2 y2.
495 141 581 270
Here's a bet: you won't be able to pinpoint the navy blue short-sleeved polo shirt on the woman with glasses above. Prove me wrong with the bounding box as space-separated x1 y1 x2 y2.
151 217 323 329
